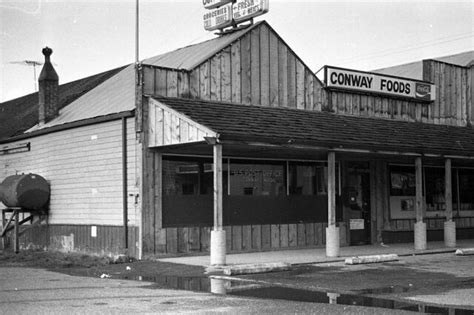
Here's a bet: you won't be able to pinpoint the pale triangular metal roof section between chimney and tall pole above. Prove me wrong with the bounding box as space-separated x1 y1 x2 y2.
27 64 135 132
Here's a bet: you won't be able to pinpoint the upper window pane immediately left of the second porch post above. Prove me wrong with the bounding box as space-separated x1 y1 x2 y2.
288 163 328 195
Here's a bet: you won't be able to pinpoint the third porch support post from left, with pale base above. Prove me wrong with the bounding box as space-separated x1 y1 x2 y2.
415 157 426 250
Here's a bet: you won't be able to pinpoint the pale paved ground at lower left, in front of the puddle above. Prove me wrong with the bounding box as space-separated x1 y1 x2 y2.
0 267 408 315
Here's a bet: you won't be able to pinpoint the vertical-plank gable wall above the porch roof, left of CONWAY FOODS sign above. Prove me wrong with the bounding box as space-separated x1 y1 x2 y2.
144 24 325 110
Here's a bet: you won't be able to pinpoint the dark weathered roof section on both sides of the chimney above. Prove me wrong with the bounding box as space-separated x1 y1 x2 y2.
0 67 128 139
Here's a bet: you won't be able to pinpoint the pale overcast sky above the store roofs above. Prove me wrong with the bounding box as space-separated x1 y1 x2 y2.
0 0 474 101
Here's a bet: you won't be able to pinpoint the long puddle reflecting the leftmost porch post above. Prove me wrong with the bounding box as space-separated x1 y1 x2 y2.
131 276 474 315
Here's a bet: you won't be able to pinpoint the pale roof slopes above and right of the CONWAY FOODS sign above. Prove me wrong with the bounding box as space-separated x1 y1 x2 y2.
372 50 474 80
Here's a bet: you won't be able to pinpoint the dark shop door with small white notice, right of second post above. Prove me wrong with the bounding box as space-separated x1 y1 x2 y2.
346 164 371 245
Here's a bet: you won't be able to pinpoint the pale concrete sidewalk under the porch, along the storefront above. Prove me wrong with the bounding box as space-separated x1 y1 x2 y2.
158 239 474 267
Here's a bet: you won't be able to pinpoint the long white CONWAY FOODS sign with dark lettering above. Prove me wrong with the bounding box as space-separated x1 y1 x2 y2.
324 66 436 101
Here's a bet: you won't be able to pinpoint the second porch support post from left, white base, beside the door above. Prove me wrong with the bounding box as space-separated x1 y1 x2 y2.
326 152 339 257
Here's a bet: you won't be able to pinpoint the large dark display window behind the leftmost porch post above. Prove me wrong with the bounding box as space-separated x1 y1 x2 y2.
162 156 336 227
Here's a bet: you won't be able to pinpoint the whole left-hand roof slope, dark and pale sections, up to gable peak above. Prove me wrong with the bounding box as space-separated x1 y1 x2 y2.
0 21 266 140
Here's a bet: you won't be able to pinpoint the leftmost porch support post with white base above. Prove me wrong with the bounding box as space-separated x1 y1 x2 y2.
211 143 226 265
